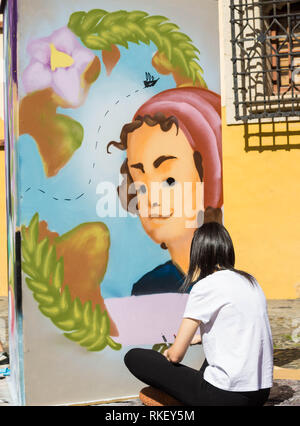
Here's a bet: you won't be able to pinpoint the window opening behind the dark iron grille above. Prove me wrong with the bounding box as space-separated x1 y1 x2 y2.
230 0 300 121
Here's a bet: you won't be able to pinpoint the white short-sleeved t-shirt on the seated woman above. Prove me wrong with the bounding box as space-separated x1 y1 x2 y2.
183 270 273 392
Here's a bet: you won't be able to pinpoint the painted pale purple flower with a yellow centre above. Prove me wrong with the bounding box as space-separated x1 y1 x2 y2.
22 27 95 107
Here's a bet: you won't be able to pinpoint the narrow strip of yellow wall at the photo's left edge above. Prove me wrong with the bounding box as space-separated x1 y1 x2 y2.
0 119 7 296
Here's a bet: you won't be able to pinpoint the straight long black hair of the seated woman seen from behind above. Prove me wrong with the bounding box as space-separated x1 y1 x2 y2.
180 222 256 292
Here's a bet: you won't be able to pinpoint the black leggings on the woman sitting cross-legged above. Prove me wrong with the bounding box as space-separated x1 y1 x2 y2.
124 348 270 406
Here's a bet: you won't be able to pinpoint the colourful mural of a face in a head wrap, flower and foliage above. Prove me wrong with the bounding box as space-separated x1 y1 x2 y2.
3 0 223 402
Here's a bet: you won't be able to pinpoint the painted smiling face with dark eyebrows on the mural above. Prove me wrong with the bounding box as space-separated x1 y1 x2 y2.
127 123 203 244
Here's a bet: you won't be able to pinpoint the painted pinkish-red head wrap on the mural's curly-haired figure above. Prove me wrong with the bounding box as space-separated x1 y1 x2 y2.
134 87 223 208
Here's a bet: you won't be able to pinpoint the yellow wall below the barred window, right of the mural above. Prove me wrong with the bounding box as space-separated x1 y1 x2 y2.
223 108 300 299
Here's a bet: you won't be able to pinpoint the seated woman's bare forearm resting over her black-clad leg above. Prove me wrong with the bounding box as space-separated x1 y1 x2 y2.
164 318 200 363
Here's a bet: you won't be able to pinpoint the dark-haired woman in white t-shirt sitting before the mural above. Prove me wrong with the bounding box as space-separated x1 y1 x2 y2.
125 222 273 406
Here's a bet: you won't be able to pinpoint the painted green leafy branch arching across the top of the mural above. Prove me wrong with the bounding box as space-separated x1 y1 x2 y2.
68 9 206 87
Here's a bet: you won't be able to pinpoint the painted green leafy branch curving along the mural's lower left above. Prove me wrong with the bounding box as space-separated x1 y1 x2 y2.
21 213 121 352
